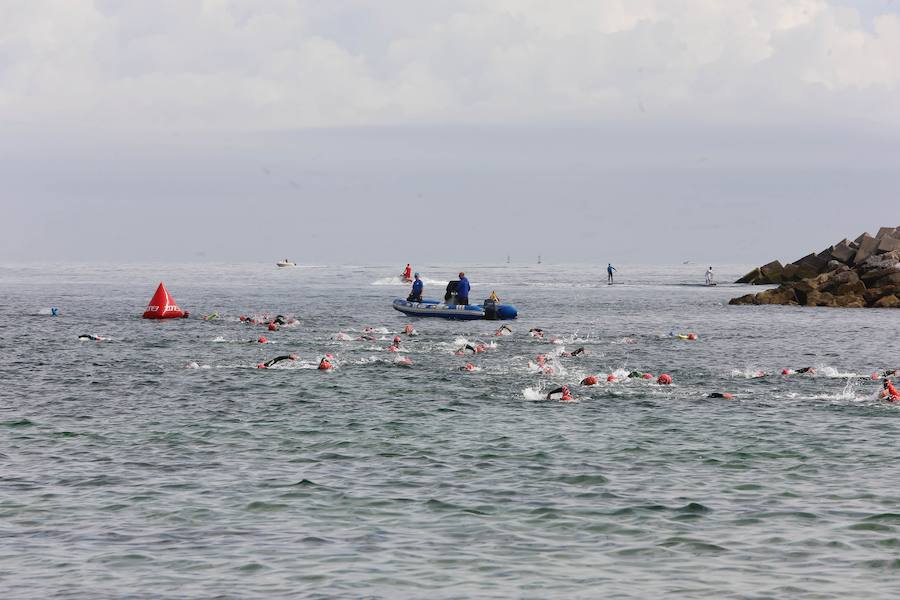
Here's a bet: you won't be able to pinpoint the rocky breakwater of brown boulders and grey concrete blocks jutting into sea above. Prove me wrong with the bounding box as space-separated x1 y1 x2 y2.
729 227 900 308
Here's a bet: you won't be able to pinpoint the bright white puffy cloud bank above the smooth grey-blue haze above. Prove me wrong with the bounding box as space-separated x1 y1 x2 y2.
0 0 900 131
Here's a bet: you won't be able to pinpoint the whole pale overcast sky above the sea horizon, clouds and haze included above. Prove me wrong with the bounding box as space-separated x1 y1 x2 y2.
0 0 900 266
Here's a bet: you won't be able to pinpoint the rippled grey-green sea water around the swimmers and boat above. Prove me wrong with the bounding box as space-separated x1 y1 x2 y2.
0 265 900 598
